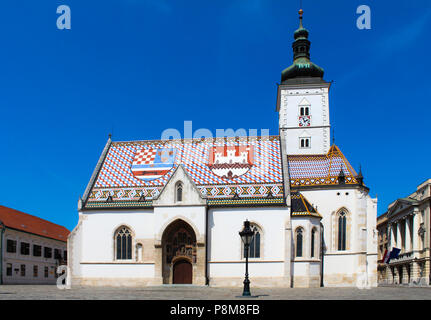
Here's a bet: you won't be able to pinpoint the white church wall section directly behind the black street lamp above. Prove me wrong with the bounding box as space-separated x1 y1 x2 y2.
208 207 290 285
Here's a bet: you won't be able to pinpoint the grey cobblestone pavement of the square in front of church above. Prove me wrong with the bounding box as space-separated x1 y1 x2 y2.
0 285 431 300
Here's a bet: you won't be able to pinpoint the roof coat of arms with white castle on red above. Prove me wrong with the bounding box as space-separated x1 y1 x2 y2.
208 145 254 179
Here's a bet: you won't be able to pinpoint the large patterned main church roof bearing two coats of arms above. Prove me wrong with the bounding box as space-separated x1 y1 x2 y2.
83 136 284 208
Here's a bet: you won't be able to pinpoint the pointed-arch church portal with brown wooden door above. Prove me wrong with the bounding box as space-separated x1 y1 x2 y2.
162 219 197 284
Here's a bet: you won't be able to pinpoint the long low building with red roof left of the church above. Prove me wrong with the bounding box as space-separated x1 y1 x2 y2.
0 206 69 284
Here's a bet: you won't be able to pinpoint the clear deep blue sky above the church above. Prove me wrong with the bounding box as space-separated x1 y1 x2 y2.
0 0 431 230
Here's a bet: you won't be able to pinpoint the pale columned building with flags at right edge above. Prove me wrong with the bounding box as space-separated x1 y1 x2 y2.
377 179 431 285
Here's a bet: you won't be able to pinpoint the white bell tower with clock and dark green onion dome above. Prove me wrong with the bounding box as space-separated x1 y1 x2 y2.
277 9 331 155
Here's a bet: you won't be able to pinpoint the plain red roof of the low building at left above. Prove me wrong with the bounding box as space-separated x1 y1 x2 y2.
0 206 70 242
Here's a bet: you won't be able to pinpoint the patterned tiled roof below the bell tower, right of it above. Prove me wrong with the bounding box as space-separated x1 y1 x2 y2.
288 145 358 188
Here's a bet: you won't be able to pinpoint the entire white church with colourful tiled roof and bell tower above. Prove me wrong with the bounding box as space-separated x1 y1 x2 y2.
68 10 377 288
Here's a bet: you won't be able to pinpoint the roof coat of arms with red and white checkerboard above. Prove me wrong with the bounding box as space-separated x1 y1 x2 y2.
131 148 177 181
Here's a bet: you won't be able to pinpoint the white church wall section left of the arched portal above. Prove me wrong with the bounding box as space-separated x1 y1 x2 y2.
69 209 156 285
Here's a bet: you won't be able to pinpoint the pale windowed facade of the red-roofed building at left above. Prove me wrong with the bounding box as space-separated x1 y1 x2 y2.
2 228 67 284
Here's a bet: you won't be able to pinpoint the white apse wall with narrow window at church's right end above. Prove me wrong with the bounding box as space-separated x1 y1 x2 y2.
300 188 377 286
